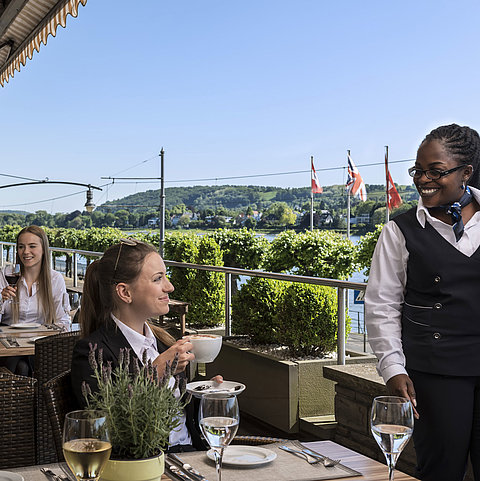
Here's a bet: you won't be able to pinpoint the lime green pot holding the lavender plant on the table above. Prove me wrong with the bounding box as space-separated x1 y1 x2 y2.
100 453 165 481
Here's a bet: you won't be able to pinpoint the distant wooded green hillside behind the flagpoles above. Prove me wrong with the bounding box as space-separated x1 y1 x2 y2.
97 184 418 212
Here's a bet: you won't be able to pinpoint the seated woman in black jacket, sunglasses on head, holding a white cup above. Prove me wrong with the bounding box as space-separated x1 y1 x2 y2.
72 239 222 452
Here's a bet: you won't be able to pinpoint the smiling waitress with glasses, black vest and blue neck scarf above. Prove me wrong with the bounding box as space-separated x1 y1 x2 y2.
365 124 480 481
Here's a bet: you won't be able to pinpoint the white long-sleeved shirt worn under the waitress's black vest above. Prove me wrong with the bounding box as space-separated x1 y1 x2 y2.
365 187 480 382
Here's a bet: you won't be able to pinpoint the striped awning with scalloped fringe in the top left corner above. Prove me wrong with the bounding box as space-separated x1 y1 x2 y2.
0 0 87 87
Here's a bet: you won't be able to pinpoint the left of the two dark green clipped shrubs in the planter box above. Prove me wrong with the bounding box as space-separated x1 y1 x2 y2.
232 277 288 344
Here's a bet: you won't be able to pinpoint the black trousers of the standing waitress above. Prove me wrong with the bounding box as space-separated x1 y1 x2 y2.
408 370 480 481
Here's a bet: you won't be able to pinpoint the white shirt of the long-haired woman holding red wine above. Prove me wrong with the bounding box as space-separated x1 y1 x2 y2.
0 269 71 330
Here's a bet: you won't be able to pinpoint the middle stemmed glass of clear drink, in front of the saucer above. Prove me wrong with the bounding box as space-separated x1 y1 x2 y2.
199 393 240 481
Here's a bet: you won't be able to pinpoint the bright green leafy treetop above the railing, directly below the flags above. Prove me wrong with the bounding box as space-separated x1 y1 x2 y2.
264 230 357 279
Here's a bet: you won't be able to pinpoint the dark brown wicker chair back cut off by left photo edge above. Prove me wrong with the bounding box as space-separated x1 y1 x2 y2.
0 369 37 469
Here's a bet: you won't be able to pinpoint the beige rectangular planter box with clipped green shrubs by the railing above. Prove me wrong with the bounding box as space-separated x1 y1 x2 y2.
205 278 375 433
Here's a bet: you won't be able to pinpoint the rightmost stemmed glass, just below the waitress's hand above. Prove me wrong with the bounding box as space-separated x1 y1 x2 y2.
370 396 413 481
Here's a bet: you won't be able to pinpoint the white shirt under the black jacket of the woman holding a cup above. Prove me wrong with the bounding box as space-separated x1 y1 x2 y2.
112 314 192 446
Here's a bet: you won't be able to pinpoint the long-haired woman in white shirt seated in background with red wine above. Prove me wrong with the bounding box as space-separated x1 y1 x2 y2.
0 225 70 375
